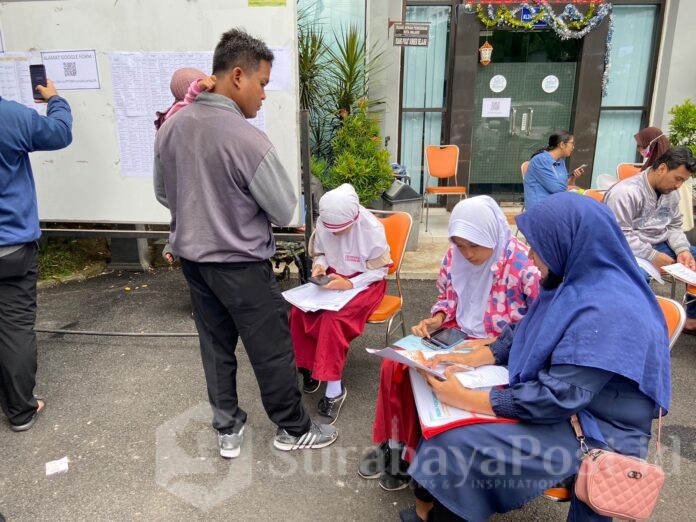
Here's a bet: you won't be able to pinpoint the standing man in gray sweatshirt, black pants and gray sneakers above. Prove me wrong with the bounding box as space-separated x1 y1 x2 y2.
155 29 337 458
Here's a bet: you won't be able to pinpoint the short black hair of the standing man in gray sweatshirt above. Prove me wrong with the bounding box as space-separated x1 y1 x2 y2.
213 28 273 74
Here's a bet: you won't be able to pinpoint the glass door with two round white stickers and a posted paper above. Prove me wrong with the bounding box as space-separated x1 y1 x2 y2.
469 31 580 201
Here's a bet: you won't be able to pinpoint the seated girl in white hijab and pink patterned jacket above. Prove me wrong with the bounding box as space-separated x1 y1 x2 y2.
358 196 539 491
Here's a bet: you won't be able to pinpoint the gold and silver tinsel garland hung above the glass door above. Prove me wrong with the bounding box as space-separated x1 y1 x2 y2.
464 0 614 96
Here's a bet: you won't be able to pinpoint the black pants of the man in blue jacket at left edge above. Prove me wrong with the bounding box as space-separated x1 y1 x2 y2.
0 242 38 425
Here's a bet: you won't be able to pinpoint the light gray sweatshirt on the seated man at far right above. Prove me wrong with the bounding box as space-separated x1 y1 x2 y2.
604 169 690 261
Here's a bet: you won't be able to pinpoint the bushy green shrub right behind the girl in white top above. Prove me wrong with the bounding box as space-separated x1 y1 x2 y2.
314 98 393 205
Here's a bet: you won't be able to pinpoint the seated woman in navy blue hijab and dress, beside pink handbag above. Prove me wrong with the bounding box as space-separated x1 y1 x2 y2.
409 193 670 522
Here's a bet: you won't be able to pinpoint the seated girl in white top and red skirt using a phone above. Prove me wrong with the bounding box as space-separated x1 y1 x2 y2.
290 183 391 424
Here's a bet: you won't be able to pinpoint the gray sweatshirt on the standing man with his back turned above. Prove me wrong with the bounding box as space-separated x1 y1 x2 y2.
154 92 297 263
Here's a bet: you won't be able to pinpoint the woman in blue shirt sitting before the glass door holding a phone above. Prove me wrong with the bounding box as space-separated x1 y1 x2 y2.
524 131 585 210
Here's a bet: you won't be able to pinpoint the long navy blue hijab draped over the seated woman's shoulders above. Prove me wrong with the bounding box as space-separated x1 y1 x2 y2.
509 193 671 413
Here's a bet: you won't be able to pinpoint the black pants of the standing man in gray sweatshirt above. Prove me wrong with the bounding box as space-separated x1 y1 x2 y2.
181 259 310 435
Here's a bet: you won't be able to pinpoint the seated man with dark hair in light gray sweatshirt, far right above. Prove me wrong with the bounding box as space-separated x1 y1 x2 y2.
604 147 696 333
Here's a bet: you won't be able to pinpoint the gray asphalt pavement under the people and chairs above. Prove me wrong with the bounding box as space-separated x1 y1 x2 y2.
0 270 696 521
